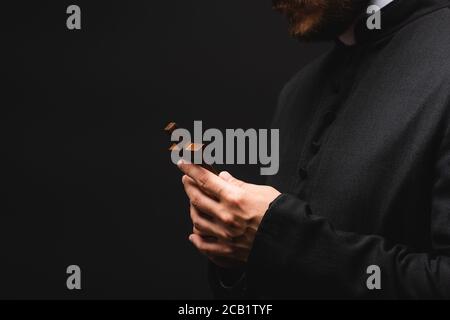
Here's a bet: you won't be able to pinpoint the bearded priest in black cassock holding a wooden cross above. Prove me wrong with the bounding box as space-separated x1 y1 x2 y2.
179 0 450 299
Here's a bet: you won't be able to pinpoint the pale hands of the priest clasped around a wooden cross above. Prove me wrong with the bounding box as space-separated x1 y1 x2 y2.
178 160 280 267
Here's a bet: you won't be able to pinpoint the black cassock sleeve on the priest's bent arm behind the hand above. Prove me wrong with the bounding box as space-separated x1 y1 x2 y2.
247 186 450 299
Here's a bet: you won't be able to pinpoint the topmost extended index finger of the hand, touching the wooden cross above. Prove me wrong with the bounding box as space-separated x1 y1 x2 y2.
178 160 230 199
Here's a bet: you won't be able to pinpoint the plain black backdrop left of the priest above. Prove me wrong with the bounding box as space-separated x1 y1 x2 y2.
0 0 328 299
